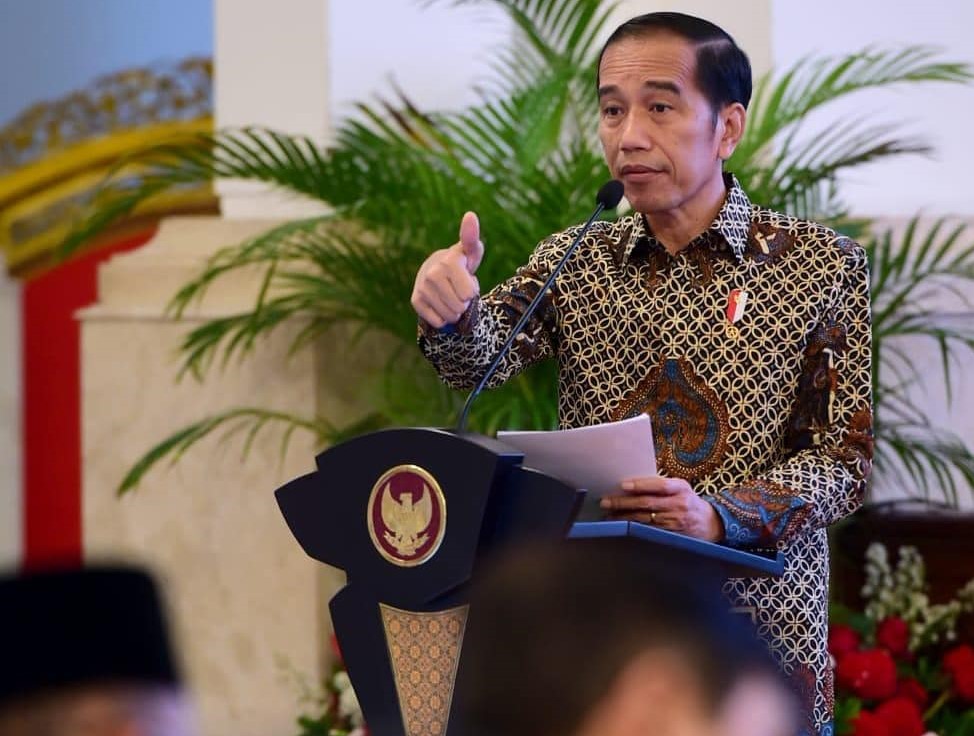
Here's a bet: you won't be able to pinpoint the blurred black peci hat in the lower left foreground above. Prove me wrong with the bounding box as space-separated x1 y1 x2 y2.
0 567 179 706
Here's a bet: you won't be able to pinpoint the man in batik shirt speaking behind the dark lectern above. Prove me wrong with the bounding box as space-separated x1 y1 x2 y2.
412 13 872 733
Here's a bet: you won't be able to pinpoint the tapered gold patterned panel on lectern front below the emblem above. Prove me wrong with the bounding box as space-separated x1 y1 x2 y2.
379 603 469 736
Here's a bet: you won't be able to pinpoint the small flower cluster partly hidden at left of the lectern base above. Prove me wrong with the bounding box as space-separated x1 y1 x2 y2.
292 634 369 736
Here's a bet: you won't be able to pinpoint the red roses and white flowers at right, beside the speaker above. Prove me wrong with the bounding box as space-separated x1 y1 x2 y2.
829 543 974 736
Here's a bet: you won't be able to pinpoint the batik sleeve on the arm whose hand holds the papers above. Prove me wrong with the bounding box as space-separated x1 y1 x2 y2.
709 238 873 547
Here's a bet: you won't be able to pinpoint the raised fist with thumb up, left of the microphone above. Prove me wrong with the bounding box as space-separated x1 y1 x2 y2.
410 212 484 328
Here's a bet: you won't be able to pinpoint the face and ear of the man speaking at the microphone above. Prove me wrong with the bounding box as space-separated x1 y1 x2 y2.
599 32 733 215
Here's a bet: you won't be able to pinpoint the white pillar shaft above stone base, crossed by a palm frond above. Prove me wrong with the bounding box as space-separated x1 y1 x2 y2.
213 0 331 219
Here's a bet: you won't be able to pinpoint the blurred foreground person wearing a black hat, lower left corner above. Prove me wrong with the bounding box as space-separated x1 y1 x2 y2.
0 566 195 736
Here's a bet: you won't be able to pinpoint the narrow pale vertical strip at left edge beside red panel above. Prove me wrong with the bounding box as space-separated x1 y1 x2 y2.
0 271 24 569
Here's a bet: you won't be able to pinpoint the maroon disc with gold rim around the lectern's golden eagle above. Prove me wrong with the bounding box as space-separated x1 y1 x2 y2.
367 465 446 567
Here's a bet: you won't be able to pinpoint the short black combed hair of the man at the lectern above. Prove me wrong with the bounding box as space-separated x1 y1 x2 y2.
596 13 752 114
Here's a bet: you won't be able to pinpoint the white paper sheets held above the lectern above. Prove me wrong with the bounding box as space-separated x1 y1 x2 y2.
497 414 657 496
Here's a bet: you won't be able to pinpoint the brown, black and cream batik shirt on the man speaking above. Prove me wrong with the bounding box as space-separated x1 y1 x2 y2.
419 176 872 734
